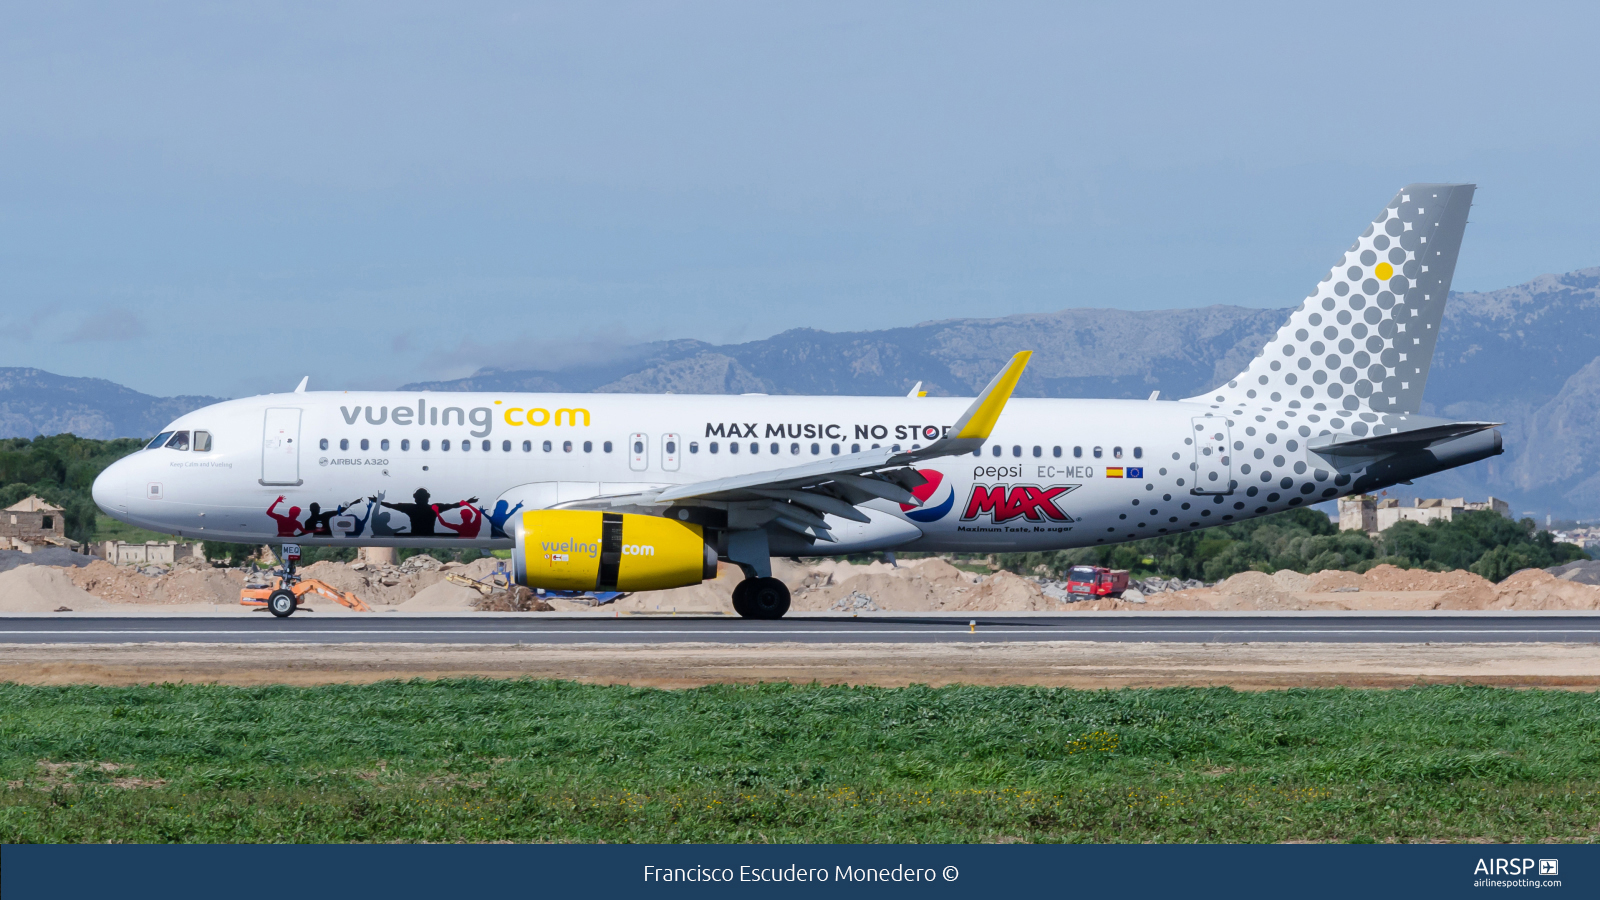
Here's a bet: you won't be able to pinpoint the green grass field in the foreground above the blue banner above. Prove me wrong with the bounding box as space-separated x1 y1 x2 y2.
0 681 1600 842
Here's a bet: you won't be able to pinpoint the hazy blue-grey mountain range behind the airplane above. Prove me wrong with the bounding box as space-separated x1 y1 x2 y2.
0 267 1600 517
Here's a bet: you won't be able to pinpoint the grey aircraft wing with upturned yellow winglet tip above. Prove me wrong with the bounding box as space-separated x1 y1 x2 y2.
562 351 1032 541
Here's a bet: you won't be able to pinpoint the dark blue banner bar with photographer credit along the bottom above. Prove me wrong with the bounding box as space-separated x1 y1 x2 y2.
0 844 1600 900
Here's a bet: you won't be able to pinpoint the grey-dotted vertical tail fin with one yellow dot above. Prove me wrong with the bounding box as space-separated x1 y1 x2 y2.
1189 184 1477 419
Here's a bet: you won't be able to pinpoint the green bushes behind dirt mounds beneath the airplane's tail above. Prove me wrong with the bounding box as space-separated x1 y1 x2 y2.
995 509 1587 581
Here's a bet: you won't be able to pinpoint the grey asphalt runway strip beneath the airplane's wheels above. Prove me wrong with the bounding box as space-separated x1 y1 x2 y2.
0 613 1600 645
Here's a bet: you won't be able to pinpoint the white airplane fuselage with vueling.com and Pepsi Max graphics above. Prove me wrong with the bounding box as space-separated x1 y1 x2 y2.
94 392 1365 554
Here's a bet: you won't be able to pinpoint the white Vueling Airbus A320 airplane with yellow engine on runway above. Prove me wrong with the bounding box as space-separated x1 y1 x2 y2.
93 184 1501 618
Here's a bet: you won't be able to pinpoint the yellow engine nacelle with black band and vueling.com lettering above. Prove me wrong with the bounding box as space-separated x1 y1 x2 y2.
515 509 717 591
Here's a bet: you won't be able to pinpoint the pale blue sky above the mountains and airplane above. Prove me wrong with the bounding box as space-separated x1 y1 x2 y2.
0 2 1600 396
